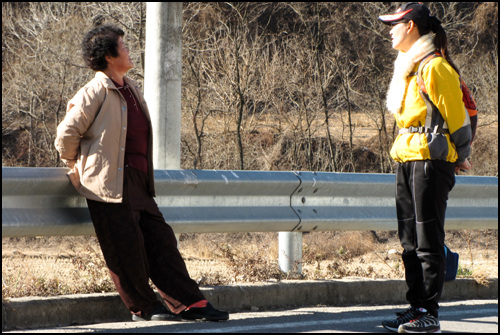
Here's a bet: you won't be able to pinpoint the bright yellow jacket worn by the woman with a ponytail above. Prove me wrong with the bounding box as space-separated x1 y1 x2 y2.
391 57 471 163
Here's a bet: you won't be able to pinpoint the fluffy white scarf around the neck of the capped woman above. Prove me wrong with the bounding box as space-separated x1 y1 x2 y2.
386 34 436 114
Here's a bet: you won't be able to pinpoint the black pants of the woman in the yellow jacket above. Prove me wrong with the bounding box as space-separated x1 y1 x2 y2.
396 160 455 317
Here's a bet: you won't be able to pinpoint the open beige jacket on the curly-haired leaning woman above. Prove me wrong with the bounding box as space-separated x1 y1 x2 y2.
55 72 155 203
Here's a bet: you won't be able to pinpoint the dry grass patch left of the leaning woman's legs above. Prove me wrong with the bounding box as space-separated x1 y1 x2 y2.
2 237 115 298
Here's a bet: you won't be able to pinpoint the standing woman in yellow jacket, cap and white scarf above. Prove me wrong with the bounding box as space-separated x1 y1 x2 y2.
379 2 471 333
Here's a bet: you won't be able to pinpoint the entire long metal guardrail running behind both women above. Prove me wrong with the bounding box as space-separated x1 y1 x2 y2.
2 167 498 237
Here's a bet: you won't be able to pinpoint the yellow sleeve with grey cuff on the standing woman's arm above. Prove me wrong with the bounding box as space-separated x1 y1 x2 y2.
422 57 472 163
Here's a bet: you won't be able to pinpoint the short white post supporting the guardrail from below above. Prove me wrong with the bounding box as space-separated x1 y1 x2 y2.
278 232 302 274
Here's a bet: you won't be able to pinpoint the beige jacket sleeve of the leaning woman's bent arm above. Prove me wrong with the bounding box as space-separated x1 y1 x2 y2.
54 86 101 167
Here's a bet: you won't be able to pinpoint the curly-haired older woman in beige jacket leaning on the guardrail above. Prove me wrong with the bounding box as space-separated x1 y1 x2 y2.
55 25 229 321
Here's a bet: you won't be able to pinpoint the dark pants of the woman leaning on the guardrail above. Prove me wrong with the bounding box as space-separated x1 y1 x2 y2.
87 167 205 316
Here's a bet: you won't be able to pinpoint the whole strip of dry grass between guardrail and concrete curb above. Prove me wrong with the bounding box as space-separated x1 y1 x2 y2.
2 230 498 299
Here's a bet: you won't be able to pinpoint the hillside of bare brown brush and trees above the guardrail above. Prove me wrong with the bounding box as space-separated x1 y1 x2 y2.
2 2 498 175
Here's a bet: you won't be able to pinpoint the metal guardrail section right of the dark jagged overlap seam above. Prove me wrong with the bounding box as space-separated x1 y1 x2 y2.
292 172 498 231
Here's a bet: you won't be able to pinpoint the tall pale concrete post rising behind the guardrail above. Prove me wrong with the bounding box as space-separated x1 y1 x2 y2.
144 2 182 170
